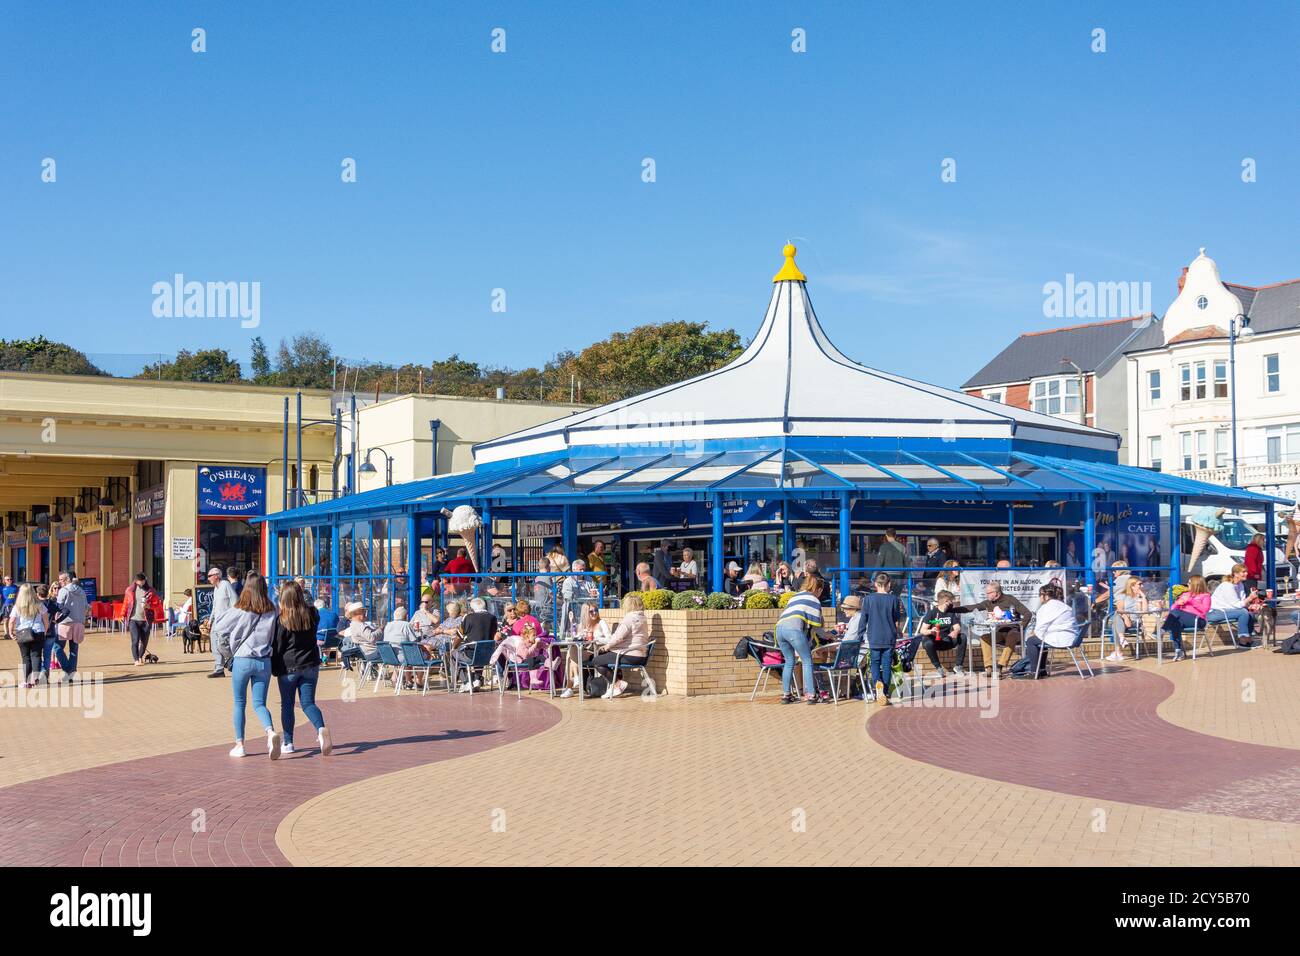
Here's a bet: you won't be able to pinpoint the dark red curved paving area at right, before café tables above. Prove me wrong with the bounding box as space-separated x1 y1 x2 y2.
867 669 1300 822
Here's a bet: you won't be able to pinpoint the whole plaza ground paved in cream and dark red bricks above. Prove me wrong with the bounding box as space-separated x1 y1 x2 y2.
0 636 1300 865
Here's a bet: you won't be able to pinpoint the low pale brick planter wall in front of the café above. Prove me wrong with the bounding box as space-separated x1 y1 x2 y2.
601 609 777 697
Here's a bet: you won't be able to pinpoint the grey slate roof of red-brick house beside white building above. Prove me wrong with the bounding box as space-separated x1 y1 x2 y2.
962 316 1149 389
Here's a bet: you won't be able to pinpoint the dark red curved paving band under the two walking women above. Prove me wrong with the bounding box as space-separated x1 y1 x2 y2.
0 693 560 866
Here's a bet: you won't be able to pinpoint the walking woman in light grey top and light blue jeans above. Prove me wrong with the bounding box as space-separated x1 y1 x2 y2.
212 571 282 760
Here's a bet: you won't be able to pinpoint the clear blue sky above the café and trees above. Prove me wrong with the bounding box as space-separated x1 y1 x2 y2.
0 0 1300 385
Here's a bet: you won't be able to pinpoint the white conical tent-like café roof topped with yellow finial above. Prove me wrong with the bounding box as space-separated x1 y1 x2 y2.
475 246 1119 463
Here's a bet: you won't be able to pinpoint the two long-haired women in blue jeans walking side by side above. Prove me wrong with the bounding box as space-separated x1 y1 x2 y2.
212 574 332 760
